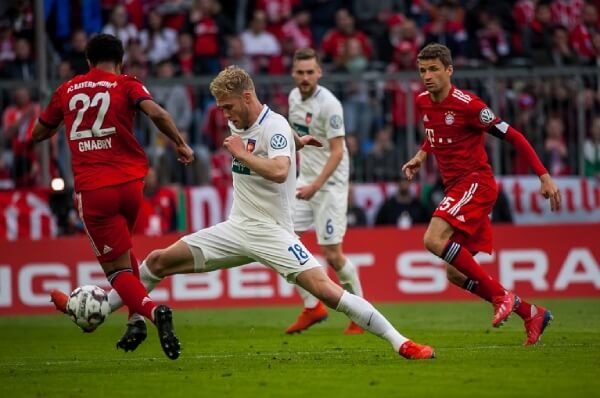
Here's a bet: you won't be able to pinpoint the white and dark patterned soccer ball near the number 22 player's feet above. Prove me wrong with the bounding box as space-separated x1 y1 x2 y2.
67 285 110 333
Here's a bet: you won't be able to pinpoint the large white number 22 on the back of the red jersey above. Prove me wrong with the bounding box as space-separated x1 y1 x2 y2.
69 91 116 140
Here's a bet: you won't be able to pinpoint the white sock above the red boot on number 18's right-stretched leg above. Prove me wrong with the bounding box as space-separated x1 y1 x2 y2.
336 291 408 352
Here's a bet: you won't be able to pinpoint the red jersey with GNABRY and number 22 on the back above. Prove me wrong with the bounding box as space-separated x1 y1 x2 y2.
39 68 152 192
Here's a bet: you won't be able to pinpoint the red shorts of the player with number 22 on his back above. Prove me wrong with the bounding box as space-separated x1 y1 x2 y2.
77 180 144 263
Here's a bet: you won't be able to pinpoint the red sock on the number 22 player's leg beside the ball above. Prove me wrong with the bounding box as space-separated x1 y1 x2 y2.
107 269 156 321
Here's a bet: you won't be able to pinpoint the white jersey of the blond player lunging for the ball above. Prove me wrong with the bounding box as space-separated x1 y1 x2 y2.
229 105 296 232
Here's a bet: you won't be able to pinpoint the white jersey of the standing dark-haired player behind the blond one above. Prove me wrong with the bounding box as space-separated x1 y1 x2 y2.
288 86 350 190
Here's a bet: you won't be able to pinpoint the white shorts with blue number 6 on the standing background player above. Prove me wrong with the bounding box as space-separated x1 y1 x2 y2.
294 187 348 246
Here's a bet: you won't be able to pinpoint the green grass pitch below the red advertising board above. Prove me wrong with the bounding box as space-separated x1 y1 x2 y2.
0 299 600 398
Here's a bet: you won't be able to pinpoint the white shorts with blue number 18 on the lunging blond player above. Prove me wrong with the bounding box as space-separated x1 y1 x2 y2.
181 220 320 283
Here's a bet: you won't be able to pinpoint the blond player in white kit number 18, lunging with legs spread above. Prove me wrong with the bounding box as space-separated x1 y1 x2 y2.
109 66 435 359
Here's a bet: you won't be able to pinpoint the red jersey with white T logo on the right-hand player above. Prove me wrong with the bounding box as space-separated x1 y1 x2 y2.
416 86 500 189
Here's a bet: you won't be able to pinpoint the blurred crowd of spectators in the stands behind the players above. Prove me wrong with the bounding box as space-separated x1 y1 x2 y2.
0 0 600 194
